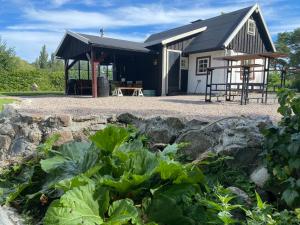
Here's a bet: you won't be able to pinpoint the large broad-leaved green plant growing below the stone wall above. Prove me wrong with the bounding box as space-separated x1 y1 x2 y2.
0 126 299 225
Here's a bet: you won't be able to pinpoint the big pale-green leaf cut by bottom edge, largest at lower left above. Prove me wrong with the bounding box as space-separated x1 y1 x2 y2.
44 185 103 225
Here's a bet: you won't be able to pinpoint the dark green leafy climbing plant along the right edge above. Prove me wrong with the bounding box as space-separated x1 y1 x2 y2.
264 89 300 207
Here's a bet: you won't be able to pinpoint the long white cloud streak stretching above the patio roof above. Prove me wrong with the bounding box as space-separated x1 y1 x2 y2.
8 3 244 31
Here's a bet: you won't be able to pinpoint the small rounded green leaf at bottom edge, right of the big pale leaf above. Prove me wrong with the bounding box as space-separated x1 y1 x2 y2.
105 199 140 225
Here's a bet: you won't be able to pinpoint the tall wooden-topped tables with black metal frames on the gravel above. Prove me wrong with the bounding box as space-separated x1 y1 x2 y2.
205 52 287 105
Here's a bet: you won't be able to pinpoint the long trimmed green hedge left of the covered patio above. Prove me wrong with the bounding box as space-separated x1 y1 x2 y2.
0 70 64 92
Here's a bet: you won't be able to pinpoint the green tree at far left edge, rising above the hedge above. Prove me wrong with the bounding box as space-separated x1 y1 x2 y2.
0 37 15 71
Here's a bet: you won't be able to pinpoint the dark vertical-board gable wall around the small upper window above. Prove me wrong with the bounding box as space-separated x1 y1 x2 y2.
228 13 272 54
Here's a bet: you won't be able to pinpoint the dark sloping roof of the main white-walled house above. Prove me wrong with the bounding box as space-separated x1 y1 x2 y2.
145 6 252 53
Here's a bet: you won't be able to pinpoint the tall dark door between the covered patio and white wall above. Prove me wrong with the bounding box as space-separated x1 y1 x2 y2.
168 51 180 94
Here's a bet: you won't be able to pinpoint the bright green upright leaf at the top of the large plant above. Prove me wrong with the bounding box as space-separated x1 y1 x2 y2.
90 126 130 153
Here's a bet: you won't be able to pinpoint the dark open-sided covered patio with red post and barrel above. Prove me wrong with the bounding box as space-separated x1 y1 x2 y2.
56 31 161 98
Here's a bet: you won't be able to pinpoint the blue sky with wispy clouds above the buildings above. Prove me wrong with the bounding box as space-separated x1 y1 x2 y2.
0 0 300 62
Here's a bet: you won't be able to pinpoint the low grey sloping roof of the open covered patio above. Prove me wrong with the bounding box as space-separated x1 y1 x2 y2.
77 33 150 52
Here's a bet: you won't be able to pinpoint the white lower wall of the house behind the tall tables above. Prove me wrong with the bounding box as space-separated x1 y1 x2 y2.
187 50 264 94
